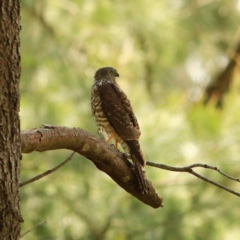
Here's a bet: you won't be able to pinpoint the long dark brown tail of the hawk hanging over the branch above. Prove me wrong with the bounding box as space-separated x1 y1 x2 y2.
126 140 147 194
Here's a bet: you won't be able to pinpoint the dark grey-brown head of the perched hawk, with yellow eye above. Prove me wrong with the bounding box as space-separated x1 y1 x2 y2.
94 67 119 82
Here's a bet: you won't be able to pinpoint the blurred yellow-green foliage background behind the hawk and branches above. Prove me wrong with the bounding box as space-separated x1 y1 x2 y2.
21 0 240 240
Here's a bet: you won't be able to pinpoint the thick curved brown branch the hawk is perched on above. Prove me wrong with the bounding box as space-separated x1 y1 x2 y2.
21 125 163 208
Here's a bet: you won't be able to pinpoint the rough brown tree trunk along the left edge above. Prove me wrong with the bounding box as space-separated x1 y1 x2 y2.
0 0 23 240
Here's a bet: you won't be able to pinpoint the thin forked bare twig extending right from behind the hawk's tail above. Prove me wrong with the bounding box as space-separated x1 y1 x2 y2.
146 161 240 197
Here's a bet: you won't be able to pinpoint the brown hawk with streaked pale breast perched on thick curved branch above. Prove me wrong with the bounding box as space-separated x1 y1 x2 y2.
91 67 147 194
